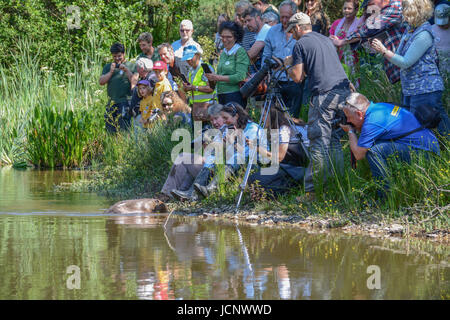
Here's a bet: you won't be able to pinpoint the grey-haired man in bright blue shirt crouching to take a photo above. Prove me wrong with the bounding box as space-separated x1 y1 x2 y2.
341 93 439 197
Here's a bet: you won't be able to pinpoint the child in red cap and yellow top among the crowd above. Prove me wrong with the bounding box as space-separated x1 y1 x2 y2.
140 61 172 128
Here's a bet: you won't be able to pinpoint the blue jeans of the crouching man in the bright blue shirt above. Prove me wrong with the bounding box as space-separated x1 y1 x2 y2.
366 141 425 198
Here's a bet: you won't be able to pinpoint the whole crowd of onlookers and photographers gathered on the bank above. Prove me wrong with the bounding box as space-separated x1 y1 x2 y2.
99 0 450 204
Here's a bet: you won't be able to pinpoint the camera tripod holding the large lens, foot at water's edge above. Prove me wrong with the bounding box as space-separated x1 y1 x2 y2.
235 67 309 213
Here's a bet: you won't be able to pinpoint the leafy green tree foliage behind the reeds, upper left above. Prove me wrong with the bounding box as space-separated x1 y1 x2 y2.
0 0 199 73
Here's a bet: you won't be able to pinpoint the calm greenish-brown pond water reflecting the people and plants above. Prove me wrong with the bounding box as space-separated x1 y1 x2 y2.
0 168 450 300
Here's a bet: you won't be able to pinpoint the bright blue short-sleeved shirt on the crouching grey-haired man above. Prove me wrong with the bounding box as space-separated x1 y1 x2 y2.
358 103 439 153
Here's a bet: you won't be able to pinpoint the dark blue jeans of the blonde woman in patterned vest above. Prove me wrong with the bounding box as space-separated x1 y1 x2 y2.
402 91 450 139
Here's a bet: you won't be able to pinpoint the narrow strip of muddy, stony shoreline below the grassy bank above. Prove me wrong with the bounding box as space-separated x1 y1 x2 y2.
168 203 450 243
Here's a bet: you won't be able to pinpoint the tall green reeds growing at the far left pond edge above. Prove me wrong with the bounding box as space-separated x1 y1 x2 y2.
0 31 105 167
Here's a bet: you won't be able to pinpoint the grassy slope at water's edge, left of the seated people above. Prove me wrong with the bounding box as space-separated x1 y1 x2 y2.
82 122 190 198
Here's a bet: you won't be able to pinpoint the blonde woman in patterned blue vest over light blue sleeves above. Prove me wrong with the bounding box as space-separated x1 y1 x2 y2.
371 0 450 139
